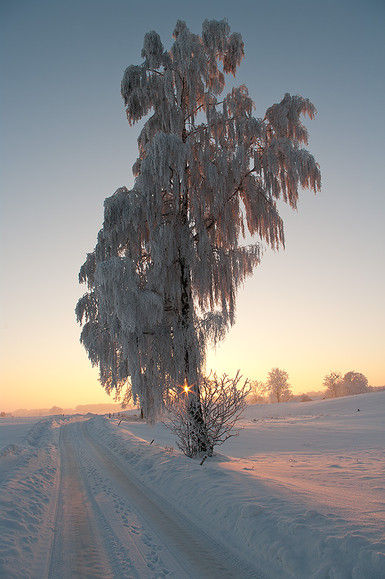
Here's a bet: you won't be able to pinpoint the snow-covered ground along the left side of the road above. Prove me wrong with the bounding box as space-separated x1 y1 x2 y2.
0 417 78 579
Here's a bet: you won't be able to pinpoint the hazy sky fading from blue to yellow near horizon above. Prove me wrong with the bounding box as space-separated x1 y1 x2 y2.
0 0 385 410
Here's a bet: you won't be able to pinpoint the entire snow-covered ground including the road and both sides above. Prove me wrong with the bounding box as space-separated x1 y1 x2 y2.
0 392 385 579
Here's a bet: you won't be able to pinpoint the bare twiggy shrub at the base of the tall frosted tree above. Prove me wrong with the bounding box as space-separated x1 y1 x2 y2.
165 372 250 458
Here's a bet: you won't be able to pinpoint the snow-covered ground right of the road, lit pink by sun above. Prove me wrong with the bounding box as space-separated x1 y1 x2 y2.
92 392 385 579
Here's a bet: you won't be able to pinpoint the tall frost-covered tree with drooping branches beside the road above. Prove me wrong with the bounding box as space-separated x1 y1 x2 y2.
77 20 320 446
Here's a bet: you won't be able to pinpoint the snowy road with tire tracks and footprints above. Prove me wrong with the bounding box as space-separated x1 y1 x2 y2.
48 421 256 579
